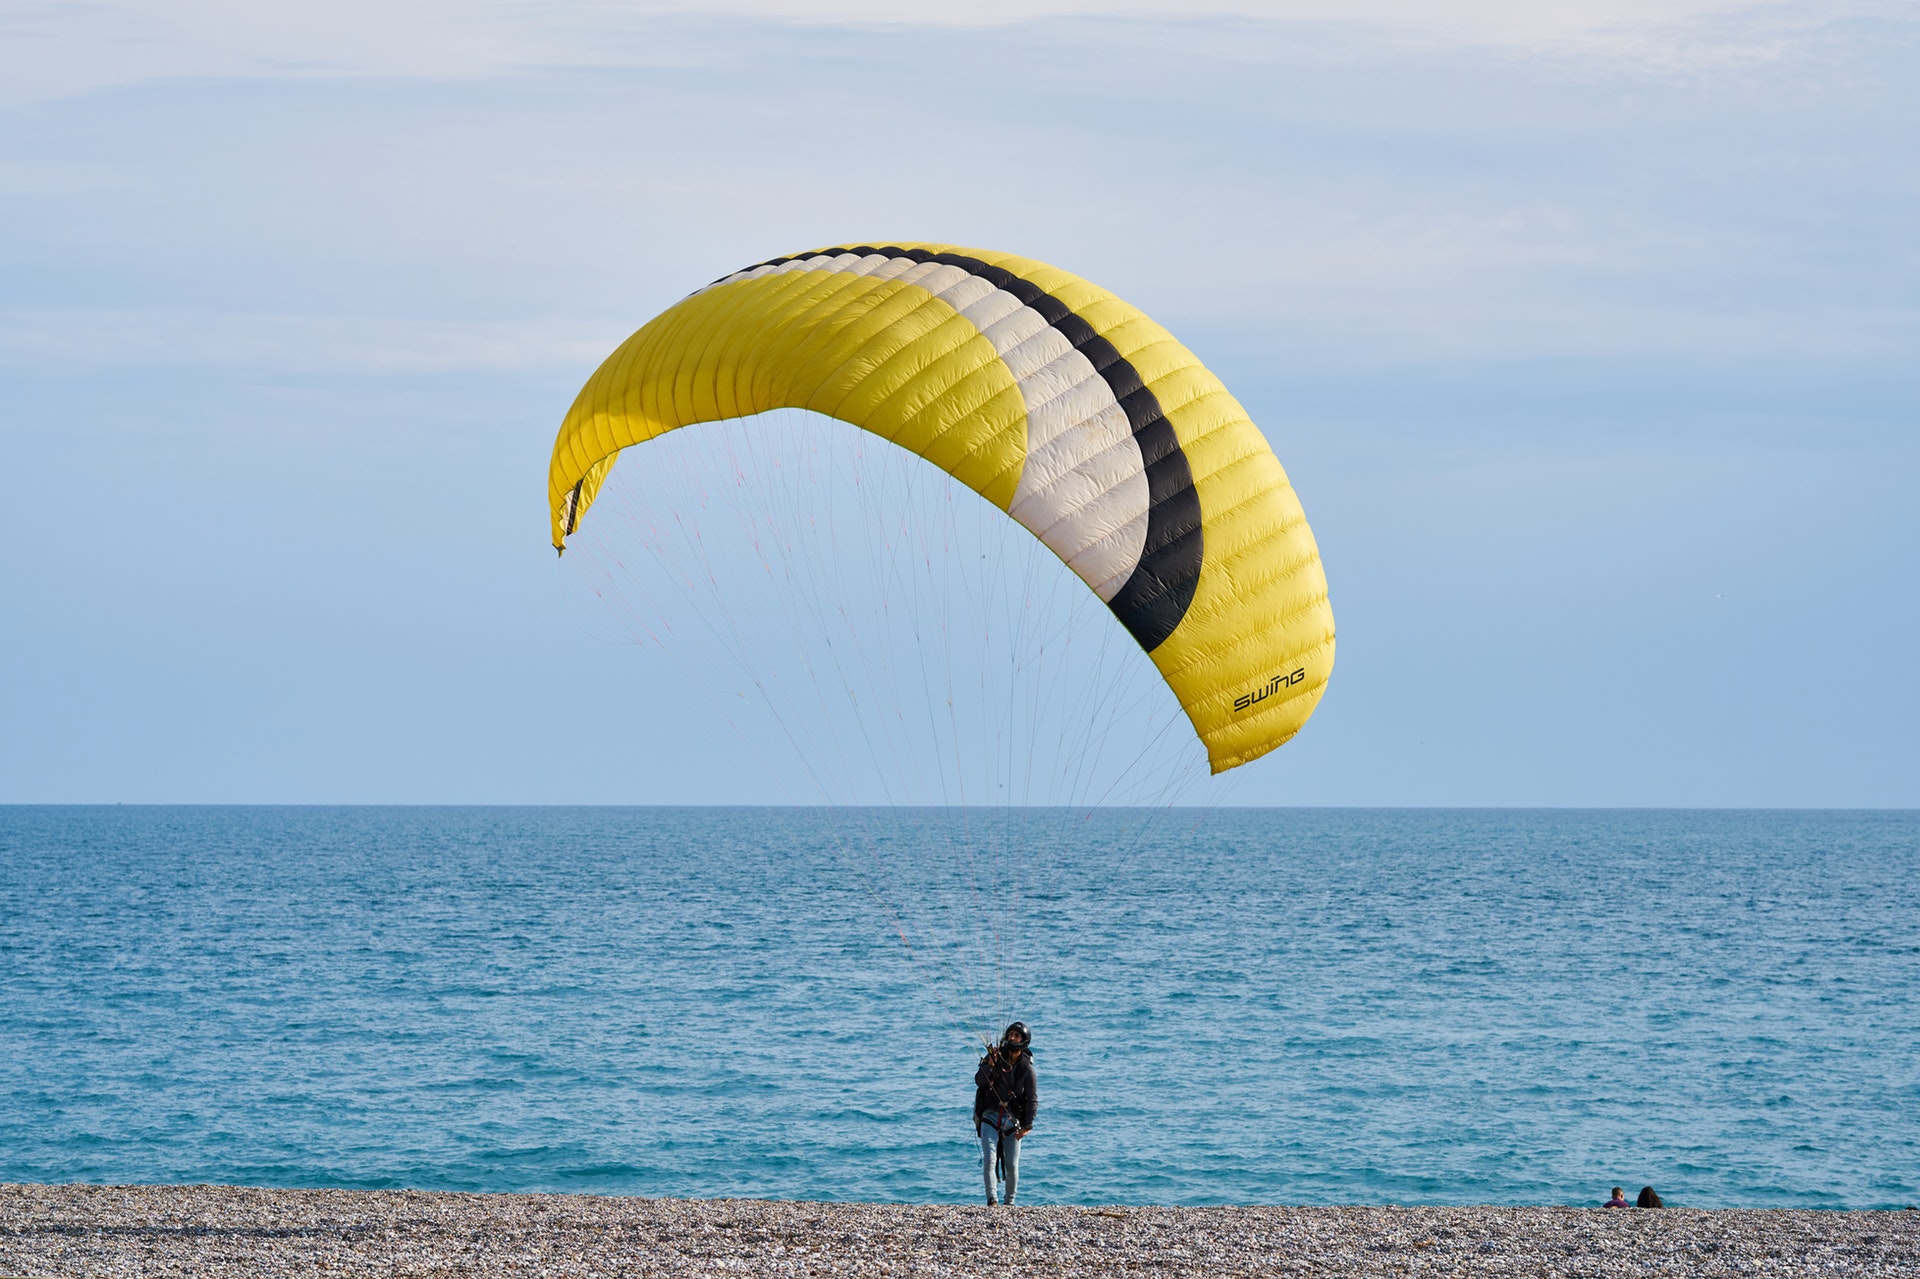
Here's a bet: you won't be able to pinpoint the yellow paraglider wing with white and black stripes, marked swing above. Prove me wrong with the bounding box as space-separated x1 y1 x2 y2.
547 244 1334 772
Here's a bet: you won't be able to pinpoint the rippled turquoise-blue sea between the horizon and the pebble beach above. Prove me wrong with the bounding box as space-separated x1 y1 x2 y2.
0 807 1920 1208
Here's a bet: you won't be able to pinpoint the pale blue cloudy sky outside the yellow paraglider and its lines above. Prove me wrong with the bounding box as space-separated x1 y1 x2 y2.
0 0 1920 807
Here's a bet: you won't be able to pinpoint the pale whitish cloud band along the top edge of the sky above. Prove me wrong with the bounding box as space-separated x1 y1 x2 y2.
0 0 1910 102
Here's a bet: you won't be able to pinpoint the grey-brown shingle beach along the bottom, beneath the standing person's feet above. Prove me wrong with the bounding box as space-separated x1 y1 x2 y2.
0 1185 1920 1277
